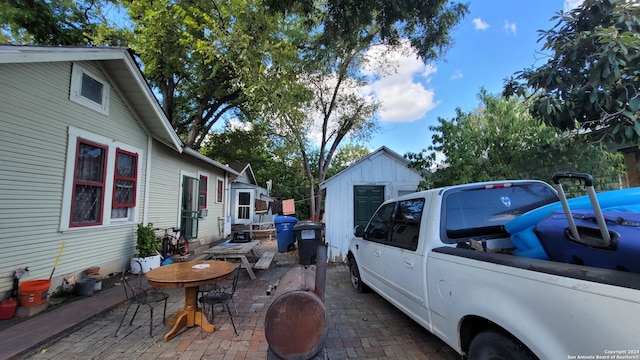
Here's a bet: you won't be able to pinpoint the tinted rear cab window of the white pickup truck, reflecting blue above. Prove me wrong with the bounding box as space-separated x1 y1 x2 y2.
441 182 558 243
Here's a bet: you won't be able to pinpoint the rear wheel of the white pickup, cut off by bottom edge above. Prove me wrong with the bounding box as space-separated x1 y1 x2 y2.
467 330 537 360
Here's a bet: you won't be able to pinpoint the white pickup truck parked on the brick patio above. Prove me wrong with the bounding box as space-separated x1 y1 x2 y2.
348 180 640 360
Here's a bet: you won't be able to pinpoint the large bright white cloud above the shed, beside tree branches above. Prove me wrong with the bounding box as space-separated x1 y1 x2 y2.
368 45 438 123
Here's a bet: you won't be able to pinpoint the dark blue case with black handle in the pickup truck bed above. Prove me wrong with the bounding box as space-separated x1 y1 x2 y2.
534 210 640 273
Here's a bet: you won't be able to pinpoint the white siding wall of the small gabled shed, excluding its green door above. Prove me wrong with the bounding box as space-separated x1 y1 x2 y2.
325 153 422 262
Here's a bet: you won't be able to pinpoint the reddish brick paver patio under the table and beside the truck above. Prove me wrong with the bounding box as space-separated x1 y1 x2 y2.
13 240 459 360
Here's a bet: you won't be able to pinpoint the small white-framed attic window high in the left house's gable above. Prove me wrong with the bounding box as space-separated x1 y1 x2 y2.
69 64 110 115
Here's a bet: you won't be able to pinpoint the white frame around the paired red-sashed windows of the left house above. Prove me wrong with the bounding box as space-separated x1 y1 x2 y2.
60 126 144 231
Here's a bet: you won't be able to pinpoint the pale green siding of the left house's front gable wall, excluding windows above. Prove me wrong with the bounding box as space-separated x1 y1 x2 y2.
0 62 147 298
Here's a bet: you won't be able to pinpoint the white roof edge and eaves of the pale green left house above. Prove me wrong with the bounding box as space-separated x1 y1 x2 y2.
0 45 240 176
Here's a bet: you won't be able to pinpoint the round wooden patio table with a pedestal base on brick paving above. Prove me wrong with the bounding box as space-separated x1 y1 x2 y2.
145 260 236 342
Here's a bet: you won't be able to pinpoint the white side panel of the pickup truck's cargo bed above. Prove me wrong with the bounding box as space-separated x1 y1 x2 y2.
427 247 640 359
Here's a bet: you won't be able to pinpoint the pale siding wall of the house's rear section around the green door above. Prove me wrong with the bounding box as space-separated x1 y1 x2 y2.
148 141 226 243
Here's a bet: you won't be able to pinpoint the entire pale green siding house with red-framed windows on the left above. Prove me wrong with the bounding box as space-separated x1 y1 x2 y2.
0 46 238 299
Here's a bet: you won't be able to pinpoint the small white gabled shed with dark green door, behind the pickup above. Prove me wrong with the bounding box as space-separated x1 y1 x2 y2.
320 146 422 262
